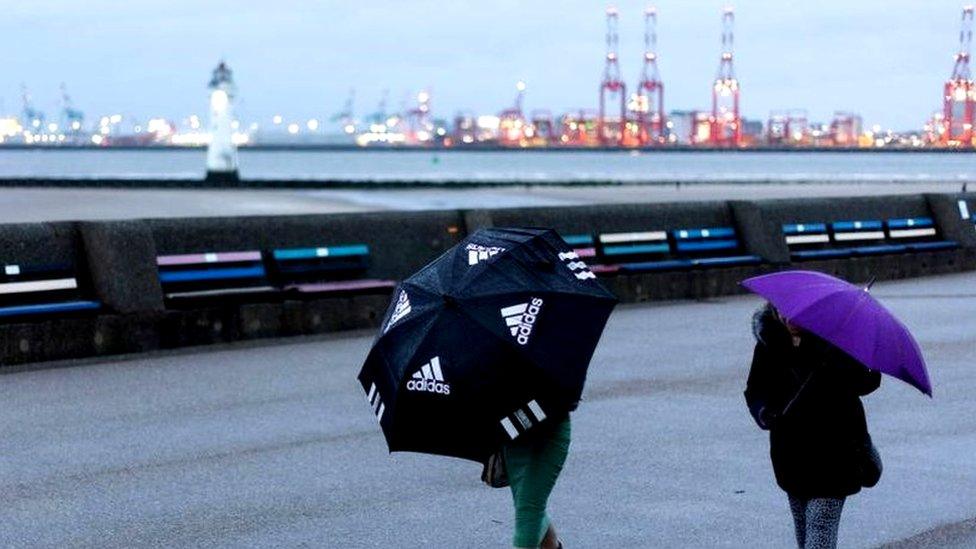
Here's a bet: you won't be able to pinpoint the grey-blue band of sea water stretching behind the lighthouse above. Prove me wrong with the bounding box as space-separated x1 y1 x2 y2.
0 150 976 182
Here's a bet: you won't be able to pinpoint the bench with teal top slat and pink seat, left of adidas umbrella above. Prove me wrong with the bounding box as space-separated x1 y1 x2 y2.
271 244 396 295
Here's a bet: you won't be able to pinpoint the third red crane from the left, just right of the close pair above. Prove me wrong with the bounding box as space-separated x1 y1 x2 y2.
709 8 742 147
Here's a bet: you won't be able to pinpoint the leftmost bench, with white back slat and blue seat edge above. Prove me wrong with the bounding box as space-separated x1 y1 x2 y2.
0 264 101 319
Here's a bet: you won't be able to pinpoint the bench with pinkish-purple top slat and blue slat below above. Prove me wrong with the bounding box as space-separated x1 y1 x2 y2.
156 250 275 301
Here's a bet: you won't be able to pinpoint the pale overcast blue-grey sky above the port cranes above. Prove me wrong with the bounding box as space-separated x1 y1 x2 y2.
0 0 962 129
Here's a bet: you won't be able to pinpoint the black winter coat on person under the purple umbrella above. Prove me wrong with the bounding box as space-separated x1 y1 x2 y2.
745 307 881 498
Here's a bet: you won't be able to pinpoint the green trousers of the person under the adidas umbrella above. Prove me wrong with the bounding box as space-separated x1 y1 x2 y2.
505 417 570 547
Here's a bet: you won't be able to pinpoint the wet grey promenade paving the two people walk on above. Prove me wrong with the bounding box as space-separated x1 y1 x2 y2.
0 274 976 548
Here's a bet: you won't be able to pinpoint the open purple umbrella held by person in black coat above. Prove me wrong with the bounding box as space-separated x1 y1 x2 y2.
742 271 932 396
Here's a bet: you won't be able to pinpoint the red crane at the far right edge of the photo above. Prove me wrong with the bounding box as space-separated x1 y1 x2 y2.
942 6 976 147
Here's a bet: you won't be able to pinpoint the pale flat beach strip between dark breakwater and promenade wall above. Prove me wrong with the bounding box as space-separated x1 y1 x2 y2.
0 182 961 223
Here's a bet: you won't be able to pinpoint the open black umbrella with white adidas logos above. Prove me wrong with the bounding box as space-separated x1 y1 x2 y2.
359 225 617 461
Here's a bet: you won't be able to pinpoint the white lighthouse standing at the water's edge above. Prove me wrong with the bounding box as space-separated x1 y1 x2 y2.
207 61 238 182
